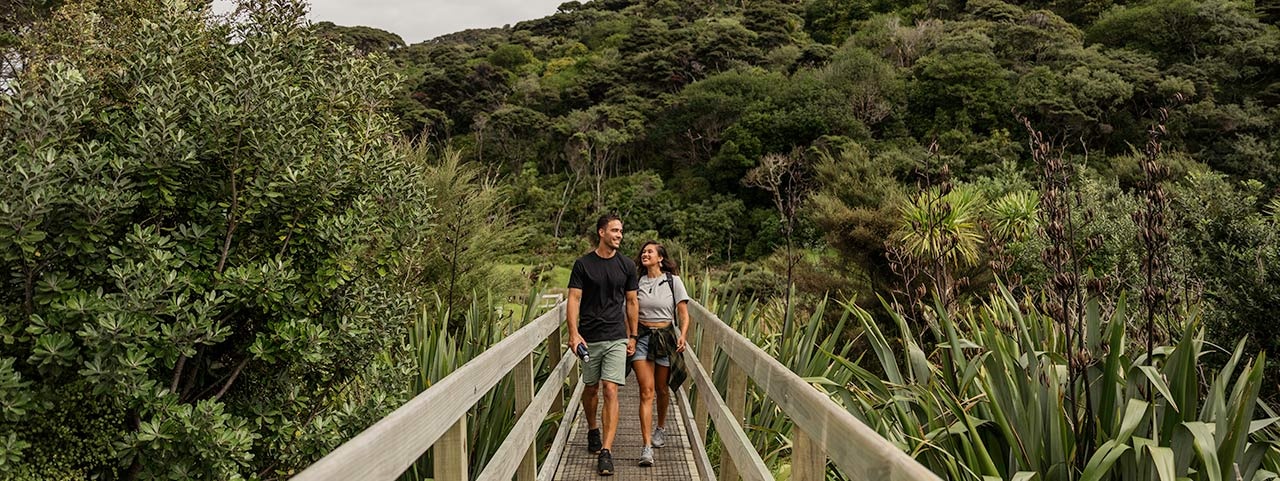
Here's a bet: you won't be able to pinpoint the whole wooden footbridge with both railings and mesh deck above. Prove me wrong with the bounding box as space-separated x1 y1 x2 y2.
293 302 938 481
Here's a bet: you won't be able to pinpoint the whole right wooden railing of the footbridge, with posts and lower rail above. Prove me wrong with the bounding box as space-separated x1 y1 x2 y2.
685 302 940 481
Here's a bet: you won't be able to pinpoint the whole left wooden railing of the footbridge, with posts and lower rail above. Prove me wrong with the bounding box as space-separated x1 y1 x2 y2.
293 302 581 481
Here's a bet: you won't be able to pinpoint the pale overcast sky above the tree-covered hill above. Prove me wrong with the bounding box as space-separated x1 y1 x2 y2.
214 0 567 43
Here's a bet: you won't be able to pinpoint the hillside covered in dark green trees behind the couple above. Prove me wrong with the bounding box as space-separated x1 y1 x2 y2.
343 0 1280 365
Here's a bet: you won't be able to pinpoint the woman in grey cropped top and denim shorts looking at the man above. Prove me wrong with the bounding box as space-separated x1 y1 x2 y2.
631 241 689 466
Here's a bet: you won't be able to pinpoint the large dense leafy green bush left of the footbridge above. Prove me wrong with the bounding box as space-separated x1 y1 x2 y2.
0 3 435 480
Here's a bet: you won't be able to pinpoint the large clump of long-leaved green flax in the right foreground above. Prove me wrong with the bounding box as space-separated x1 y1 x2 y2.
831 288 1280 481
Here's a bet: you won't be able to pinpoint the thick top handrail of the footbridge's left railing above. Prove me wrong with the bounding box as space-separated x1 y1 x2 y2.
293 302 577 481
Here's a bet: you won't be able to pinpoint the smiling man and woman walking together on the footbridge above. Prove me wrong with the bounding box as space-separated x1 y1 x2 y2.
566 214 689 476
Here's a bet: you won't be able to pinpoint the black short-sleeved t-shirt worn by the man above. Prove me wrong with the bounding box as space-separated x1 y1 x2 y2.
568 251 640 343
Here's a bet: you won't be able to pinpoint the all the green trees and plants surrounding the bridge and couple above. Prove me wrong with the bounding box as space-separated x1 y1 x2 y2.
0 0 1280 481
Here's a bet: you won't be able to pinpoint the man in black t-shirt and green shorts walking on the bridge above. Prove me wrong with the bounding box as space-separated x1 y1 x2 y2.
566 214 640 476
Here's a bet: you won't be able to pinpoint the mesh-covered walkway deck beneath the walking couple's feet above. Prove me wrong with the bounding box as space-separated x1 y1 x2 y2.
556 374 698 481
